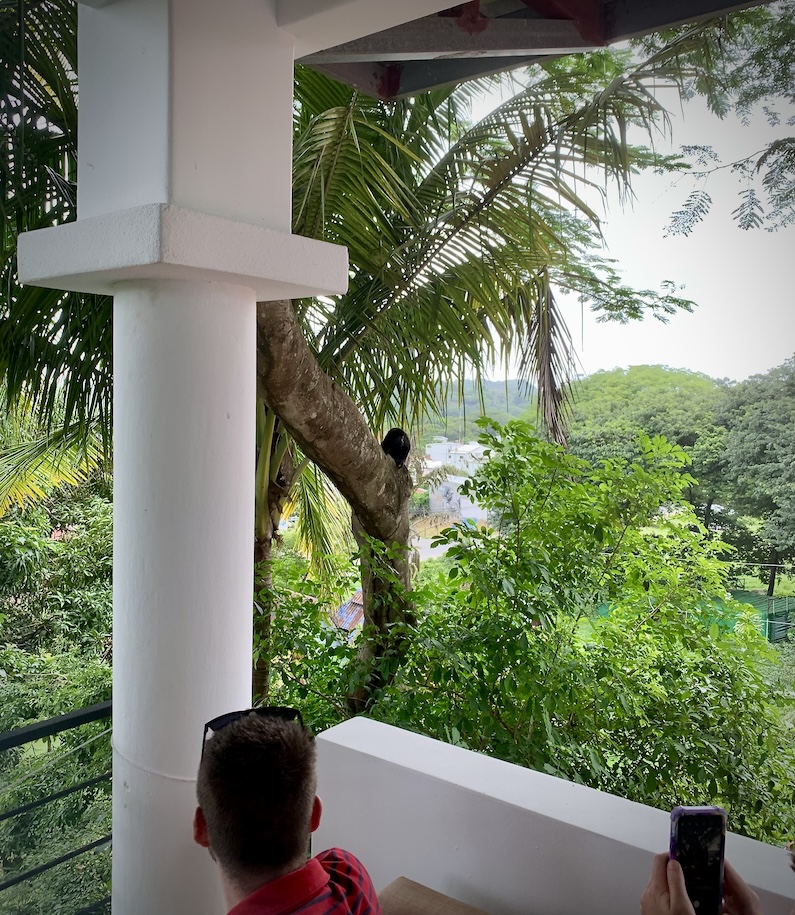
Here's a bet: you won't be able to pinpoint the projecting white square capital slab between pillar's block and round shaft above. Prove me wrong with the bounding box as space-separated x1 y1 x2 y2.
18 203 348 301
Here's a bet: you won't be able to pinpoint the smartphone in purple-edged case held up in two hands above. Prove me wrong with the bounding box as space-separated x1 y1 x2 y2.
670 807 726 915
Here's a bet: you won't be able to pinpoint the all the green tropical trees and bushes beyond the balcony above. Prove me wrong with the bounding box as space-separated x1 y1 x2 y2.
0 0 795 911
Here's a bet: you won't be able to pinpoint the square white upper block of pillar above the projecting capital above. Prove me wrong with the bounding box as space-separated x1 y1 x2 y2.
77 0 294 232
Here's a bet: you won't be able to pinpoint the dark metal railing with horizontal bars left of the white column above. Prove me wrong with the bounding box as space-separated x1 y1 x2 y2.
0 701 112 915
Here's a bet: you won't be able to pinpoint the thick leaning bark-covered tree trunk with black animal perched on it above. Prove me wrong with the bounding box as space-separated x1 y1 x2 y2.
257 301 413 704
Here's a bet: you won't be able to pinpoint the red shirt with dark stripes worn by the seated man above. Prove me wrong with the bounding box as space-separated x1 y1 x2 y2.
229 848 381 915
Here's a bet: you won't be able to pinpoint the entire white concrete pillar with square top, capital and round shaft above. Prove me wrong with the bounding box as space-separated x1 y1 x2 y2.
18 0 380 915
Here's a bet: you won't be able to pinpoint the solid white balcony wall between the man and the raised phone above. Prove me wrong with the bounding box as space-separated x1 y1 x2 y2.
314 718 795 915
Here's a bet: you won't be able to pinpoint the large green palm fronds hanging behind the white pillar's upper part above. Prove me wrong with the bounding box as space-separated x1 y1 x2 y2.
0 11 752 458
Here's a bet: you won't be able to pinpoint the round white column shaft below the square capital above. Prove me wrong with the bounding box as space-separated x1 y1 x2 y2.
113 280 256 915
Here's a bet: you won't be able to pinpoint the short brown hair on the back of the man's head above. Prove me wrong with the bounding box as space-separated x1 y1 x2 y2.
196 715 317 877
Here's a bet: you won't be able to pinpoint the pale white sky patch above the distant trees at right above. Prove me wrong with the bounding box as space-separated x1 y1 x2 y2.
476 77 795 380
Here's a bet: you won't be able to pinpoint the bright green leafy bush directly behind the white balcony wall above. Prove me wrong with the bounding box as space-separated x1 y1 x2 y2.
375 424 795 841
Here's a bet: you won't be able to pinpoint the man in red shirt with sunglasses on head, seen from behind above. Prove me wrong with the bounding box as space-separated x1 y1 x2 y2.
193 707 381 915
